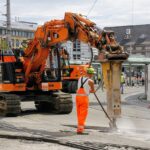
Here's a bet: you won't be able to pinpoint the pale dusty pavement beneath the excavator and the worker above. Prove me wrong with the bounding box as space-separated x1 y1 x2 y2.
0 87 150 150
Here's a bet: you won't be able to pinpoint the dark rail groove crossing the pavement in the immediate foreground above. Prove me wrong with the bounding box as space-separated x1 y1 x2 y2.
0 134 149 150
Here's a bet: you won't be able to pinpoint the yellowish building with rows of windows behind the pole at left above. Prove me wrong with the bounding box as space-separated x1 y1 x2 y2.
0 21 37 48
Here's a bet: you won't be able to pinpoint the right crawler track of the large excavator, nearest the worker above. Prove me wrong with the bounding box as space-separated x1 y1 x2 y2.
35 92 73 114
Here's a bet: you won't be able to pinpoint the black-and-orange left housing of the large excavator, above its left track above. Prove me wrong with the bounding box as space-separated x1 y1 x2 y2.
0 50 25 92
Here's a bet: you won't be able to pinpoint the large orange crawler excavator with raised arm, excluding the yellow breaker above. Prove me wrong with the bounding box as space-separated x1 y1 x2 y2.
0 12 126 116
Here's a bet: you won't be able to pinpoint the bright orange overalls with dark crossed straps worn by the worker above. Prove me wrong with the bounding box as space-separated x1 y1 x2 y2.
76 77 89 133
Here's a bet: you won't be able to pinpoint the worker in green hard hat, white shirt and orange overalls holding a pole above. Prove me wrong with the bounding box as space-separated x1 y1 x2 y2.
76 67 95 134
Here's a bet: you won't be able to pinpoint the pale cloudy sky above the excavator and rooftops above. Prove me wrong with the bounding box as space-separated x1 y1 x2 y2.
0 0 150 27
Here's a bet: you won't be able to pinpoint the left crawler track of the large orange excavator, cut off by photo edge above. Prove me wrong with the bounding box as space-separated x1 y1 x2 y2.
0 93 21 116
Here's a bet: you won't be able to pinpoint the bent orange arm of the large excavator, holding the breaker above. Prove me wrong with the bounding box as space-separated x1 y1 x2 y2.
24 12 127 83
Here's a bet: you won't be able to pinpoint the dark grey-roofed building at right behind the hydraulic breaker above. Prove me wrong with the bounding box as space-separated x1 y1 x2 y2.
105 24 150 57
